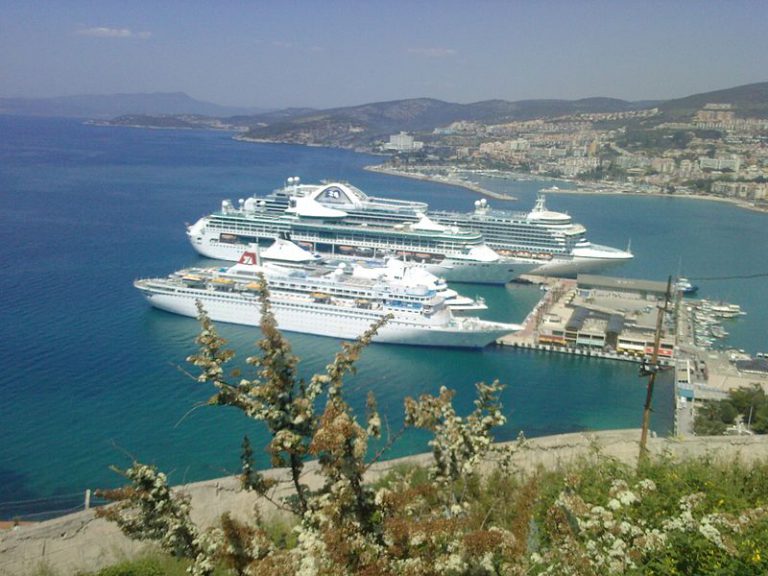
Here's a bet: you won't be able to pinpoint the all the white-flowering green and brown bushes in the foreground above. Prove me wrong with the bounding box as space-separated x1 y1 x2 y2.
97 286 768 576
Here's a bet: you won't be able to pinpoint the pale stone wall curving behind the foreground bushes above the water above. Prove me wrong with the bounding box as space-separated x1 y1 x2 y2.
6 429 768 576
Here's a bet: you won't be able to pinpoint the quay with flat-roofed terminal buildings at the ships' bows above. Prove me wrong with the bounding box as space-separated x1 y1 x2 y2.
498 274 768 437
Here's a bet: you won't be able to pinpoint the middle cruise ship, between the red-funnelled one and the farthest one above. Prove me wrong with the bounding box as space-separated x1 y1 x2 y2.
187 179 540 284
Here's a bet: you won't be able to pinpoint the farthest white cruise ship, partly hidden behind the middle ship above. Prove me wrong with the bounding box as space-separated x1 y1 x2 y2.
214 178 633 277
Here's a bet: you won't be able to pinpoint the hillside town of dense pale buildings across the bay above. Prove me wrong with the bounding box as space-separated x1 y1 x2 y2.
380 103 768 208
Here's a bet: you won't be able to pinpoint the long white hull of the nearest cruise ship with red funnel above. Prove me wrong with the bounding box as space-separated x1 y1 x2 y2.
136 281 517 348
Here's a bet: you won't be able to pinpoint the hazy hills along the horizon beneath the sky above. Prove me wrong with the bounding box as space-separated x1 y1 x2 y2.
0 82 768 147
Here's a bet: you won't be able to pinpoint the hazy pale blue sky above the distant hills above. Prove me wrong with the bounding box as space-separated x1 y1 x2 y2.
0 0 768 108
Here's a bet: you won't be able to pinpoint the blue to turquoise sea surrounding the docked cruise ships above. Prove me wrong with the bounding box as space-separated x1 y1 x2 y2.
0 116 768 520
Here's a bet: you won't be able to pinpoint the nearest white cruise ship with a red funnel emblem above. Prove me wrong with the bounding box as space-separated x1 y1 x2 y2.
134 244 520 348
